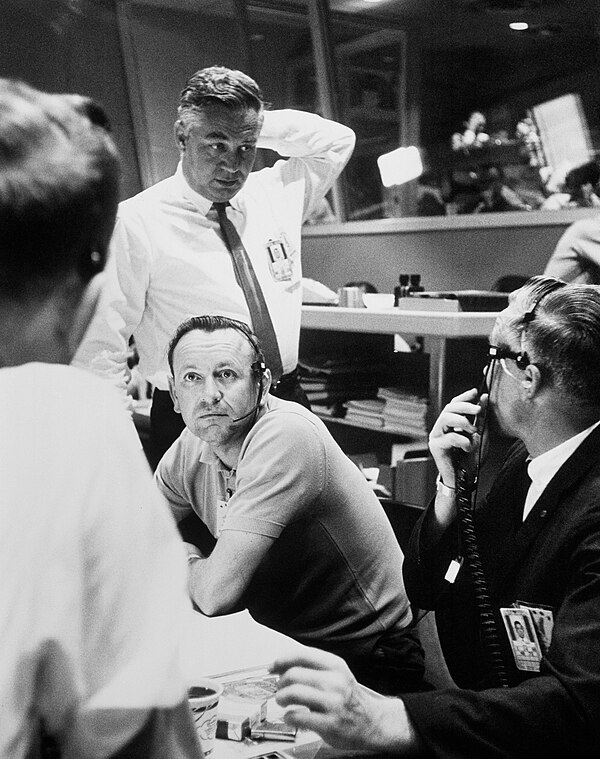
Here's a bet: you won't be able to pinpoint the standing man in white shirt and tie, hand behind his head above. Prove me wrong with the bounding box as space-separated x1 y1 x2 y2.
75 66 355 470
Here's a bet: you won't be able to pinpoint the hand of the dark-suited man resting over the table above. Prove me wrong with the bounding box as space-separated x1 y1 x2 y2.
271 647 423 756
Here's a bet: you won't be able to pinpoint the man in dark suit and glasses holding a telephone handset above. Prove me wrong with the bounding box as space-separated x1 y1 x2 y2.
273 277 600 758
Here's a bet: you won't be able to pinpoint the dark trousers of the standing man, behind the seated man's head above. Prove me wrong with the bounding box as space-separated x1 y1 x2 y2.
146 369 310 470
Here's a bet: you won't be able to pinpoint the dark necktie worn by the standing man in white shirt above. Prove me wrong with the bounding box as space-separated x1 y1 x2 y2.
213 203 283 384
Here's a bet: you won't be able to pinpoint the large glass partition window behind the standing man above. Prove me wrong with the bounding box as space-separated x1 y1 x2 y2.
115 0 600 228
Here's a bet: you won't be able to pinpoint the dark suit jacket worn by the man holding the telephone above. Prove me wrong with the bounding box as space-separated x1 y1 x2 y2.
403 428 600 759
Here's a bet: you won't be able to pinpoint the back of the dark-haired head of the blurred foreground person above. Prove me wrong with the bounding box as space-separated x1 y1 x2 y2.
0 79 119 301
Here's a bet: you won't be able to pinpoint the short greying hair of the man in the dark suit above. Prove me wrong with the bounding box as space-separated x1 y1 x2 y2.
507 276 600 408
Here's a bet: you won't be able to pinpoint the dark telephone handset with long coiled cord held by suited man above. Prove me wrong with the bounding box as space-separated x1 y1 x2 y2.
453 377 508 688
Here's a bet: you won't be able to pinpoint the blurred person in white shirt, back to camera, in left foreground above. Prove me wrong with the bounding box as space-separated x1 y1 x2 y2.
0 79 201 759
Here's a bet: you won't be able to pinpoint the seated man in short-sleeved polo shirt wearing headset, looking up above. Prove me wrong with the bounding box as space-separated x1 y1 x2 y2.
155 316 423 693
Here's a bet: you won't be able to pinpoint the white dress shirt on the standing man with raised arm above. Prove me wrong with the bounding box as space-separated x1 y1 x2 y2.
74 110 355 400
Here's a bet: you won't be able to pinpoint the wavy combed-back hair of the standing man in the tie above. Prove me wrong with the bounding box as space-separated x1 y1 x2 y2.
177 66 264 127
